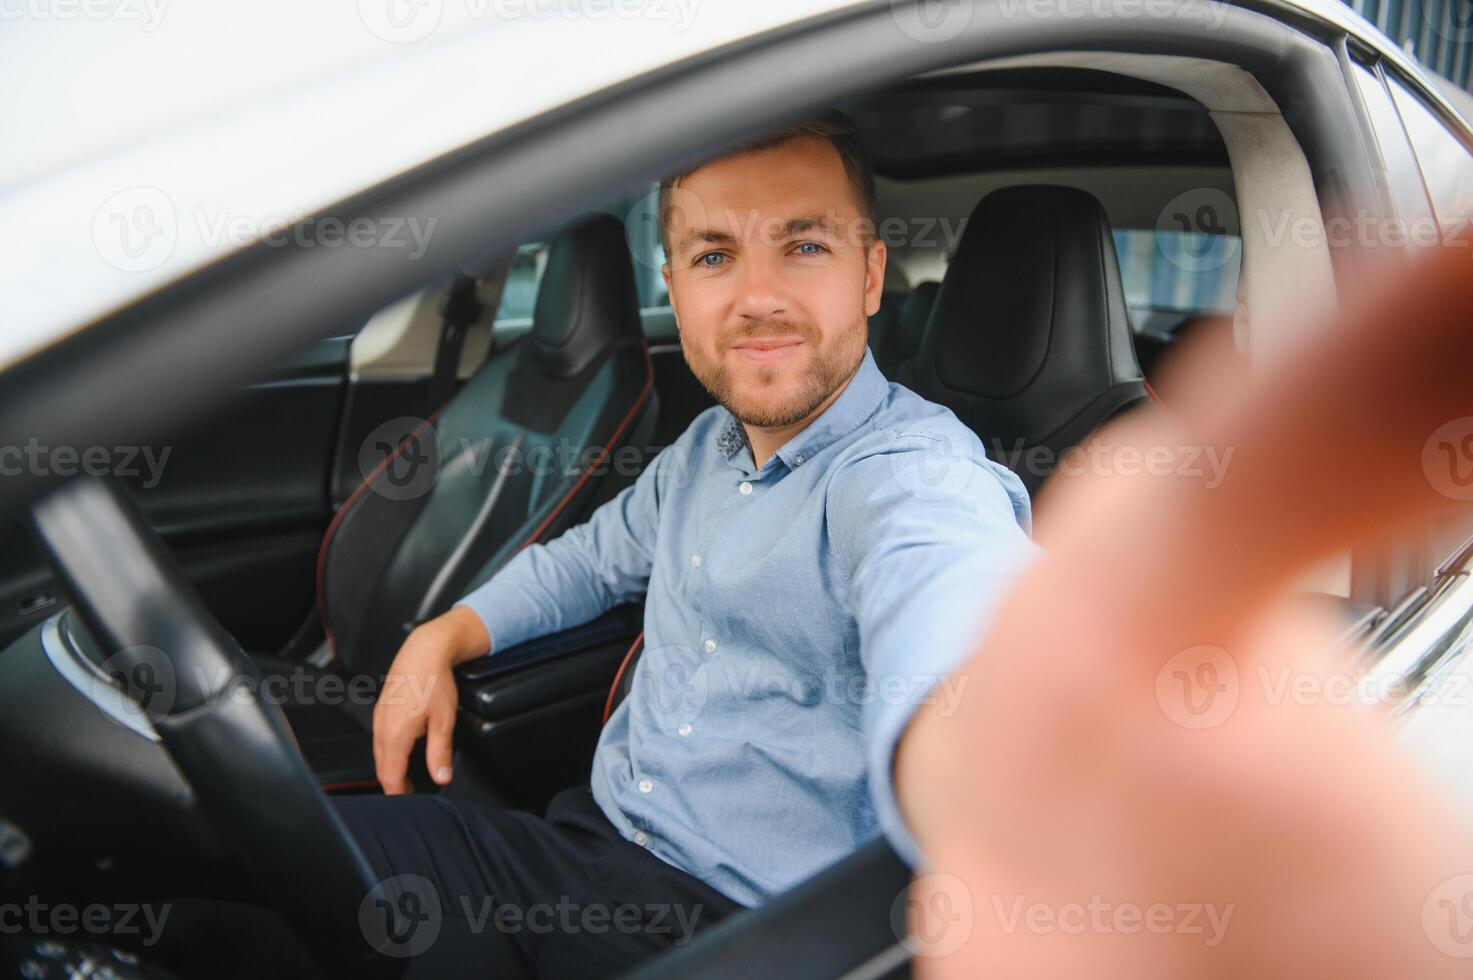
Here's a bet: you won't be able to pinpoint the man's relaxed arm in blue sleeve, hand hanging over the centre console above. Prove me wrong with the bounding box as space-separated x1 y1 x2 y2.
373 452 667 794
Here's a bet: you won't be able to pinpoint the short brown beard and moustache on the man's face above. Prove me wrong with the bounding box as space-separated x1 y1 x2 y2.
681 320 865 429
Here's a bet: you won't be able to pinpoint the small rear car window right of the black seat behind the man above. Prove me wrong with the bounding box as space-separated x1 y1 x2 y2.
1114 228 1243 329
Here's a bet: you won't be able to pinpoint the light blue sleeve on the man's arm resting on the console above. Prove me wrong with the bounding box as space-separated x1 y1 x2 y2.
455 449 669 651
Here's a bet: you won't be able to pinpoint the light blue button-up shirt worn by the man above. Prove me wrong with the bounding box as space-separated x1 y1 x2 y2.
461 351 1036 906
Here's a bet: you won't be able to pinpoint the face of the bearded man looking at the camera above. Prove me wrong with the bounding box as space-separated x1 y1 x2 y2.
663 137 885 429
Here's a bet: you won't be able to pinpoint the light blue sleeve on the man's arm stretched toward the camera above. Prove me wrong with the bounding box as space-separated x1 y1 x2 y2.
826 423 1037 867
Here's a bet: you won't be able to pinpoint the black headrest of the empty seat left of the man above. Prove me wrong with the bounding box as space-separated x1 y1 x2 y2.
527 214 642 377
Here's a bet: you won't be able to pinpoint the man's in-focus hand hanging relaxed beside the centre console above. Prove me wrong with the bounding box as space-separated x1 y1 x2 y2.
373 606 491 796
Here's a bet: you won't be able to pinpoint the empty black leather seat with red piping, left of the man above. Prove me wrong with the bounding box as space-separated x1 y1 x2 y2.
261 215 655 783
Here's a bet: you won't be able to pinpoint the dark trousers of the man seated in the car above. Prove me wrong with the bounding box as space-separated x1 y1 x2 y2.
334 787 741 980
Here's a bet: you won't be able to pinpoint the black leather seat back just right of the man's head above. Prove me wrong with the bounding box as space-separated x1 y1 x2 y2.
907 184 1147 491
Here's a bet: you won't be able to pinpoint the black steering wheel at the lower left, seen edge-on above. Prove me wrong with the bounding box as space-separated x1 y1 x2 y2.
32 479 405 977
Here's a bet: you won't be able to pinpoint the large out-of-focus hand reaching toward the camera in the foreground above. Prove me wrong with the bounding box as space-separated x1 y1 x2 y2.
896 249 1473 980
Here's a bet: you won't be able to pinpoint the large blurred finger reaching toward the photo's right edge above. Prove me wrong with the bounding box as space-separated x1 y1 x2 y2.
1036 249 1473 657
